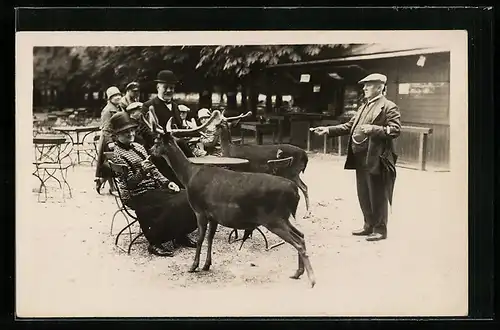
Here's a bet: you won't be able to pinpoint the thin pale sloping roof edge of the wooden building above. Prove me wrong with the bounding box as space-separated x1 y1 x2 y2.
266 47 450 68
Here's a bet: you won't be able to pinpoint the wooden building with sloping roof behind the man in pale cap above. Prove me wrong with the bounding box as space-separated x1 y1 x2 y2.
266 44 450 169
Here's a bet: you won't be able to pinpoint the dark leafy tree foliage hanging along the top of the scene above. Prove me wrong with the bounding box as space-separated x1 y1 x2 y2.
33 45 348 90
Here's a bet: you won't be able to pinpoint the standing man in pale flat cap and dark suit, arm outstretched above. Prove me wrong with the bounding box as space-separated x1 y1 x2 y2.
312 73 401 241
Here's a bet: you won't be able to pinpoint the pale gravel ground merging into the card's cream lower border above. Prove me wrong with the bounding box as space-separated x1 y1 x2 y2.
16 154 468 317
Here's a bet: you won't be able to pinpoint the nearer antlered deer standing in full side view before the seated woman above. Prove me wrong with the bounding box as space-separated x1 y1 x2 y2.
145 110 316 288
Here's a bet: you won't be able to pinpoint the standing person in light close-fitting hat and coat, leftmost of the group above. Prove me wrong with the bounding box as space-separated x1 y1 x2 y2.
94 86 123 194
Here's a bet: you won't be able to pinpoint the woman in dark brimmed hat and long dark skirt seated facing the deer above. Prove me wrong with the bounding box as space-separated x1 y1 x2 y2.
110 112 197 257
